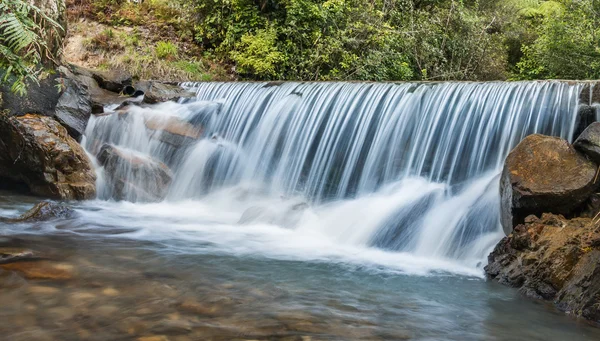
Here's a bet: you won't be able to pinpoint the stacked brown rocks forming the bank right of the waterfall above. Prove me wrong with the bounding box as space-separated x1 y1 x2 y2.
485 123 600 322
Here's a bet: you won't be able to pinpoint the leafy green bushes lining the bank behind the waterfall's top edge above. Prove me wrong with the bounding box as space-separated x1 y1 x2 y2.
71 0 600 81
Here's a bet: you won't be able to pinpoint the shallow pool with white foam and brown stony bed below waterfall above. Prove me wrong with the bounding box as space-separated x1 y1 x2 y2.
0 193 600 341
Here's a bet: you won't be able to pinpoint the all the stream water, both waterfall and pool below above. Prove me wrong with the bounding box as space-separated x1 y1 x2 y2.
0 82 600 340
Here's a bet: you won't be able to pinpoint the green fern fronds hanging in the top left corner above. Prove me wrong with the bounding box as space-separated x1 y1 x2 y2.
0 0 62 95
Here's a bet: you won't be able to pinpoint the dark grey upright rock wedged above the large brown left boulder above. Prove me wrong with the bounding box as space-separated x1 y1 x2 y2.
54 78 92 141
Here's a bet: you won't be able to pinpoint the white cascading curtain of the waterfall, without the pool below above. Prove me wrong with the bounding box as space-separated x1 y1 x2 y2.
86 82 581 268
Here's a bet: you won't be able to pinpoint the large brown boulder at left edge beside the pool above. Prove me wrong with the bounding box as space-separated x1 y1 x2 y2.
0 114 96 200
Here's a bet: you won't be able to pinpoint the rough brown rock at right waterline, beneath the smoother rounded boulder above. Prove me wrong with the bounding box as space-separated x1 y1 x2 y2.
485 214 600 322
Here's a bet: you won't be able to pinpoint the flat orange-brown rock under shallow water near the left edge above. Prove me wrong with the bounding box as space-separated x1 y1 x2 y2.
0 261 73 281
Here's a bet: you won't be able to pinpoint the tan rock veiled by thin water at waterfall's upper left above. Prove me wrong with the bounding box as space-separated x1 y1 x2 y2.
144 116 203 147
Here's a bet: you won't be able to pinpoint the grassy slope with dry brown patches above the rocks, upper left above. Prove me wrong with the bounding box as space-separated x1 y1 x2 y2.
67 0 231 81
